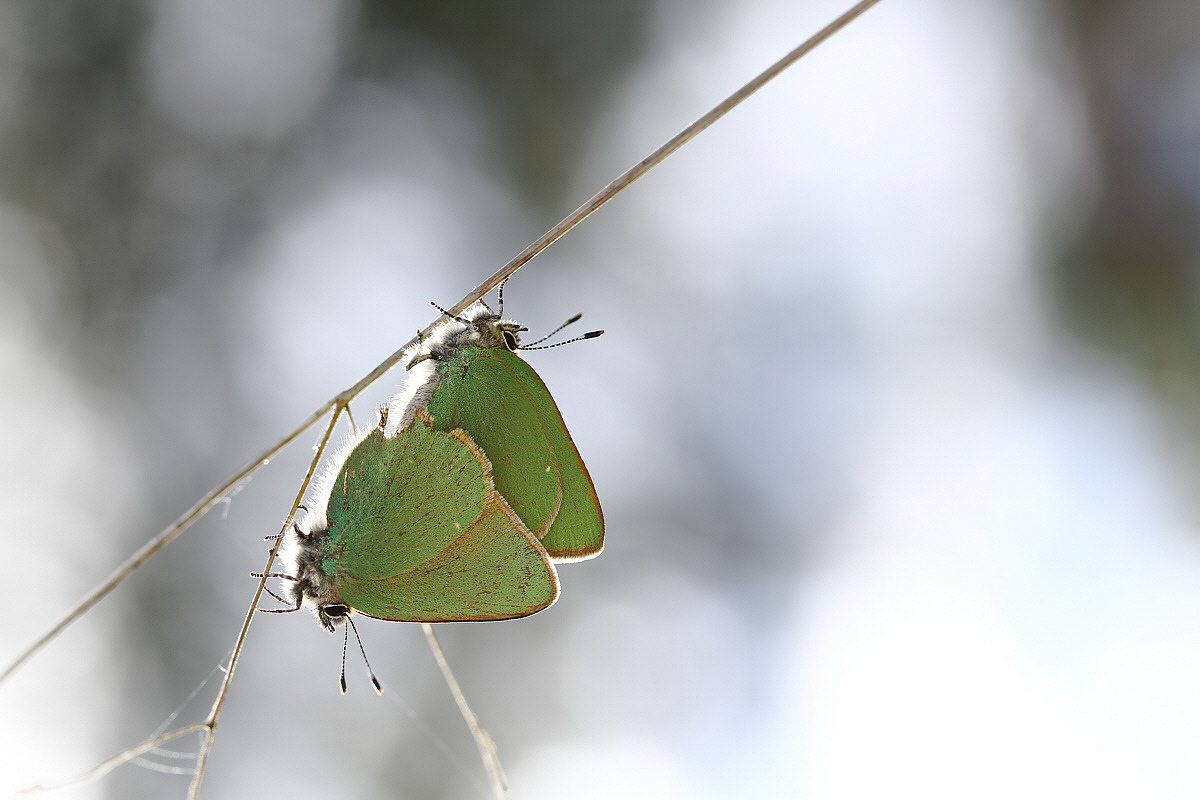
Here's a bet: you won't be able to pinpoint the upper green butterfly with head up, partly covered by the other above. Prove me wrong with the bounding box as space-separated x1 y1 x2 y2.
391 293 604 561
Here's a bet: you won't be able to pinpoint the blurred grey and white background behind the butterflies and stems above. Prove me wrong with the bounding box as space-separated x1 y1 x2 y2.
0 0 1200 799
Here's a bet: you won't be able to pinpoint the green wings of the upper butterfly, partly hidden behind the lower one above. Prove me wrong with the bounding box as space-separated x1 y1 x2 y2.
427 348 604 560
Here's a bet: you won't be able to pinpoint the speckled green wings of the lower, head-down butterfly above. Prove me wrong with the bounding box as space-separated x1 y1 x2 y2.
325 415 558 622
